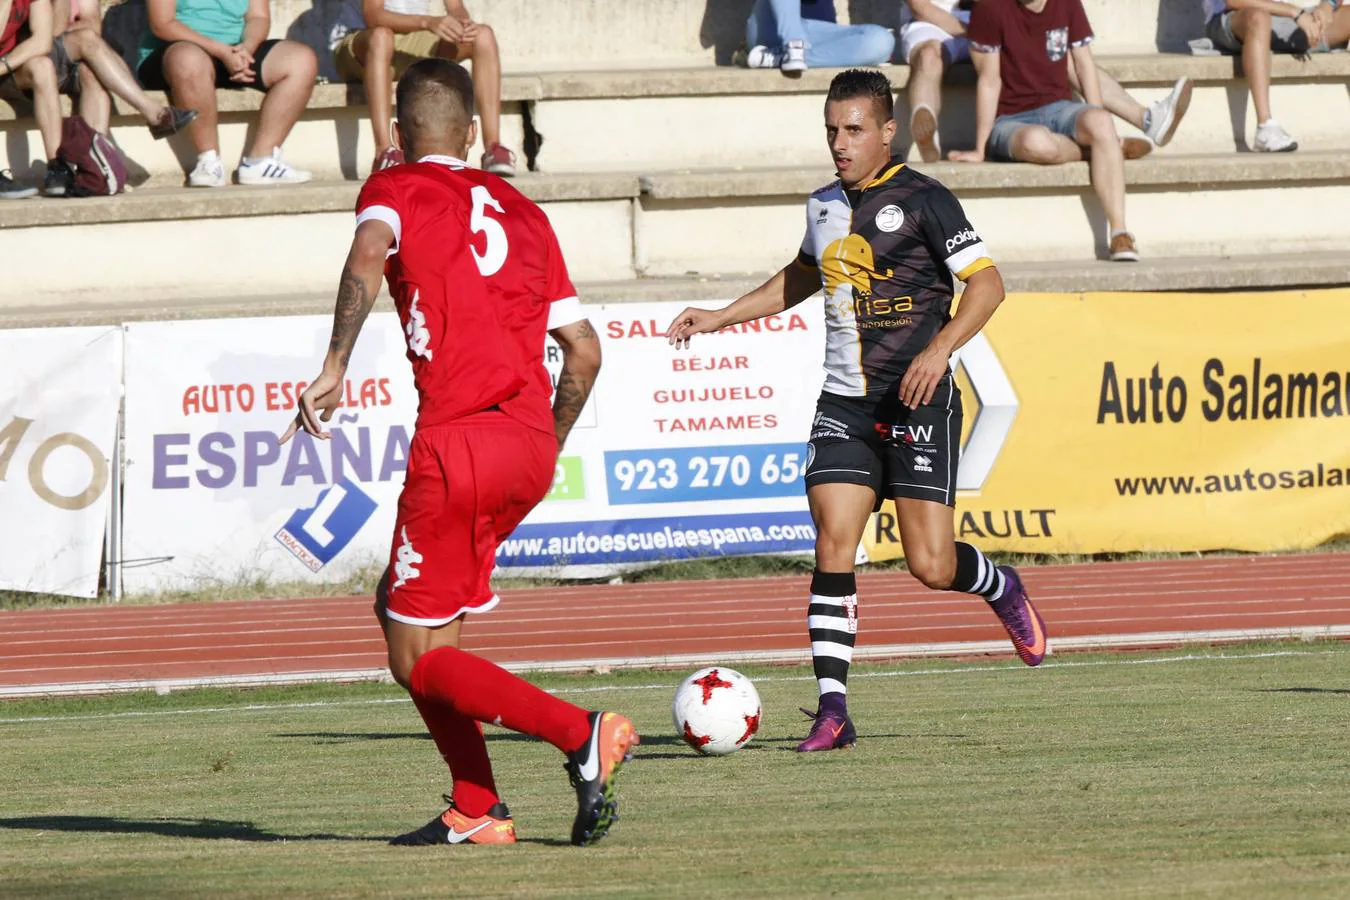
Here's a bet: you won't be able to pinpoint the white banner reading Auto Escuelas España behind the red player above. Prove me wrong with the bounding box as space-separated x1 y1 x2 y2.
123 300 824 592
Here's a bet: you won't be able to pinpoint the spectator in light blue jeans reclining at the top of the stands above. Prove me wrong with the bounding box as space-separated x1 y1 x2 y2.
737 0 895 77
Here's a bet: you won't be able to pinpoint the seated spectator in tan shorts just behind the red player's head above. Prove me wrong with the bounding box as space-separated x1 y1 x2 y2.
333 0 516 178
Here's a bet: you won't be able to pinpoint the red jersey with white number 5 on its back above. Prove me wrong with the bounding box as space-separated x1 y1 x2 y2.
356 157 582 434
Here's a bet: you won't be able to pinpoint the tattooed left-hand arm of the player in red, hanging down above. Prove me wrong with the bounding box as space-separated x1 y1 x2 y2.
281 220 394 444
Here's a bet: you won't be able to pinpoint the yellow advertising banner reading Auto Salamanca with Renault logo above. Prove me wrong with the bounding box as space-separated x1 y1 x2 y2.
864 289 1350 560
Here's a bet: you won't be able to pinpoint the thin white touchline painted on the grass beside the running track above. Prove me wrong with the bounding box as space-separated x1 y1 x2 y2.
0 650 1341 726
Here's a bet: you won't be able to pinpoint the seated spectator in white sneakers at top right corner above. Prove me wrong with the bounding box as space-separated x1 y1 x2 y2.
1204 0 1350 152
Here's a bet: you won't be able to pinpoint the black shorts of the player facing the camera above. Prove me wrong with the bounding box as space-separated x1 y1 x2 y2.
806 374 961 507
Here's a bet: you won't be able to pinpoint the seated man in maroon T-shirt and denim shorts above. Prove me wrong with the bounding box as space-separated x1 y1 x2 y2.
950 0 1139 262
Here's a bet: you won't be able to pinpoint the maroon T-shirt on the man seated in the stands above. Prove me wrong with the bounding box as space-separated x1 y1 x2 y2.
965 0 1092 116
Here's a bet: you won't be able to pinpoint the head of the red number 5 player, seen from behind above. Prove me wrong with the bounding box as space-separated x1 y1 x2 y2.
397 57 474 161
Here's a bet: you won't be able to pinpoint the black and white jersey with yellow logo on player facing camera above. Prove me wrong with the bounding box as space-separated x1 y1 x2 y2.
798 159 994 398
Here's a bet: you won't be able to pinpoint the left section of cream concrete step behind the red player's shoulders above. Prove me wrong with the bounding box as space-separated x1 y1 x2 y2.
0 174 640 304
